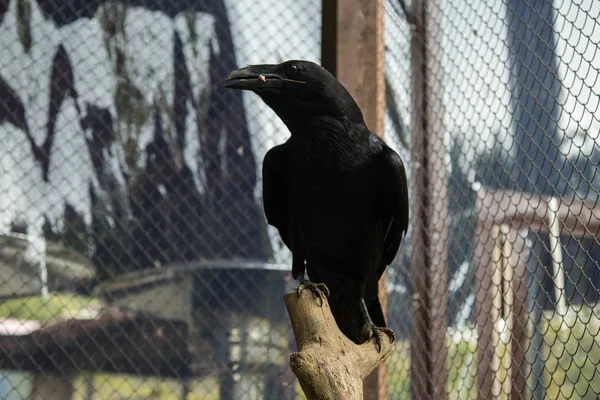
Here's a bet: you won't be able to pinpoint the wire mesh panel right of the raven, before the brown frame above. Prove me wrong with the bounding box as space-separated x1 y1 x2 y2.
385 0 600 399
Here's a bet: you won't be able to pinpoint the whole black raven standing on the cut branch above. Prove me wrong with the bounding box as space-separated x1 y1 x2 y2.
225 60 408 349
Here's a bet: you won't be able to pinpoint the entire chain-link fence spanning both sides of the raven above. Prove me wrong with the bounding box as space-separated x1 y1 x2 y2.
0 0 600 400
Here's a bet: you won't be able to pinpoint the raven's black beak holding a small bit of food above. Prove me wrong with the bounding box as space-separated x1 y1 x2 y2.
223 64 305 92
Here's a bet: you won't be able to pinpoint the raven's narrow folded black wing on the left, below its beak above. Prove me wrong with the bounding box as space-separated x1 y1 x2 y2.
262 143 294 251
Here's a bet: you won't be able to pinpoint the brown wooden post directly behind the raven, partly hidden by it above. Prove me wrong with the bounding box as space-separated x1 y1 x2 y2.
321 0 387 400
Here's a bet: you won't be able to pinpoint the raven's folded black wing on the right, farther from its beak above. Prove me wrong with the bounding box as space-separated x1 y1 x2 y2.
377 144 409 278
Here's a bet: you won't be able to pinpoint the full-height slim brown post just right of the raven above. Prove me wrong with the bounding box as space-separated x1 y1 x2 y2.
410 0 448 399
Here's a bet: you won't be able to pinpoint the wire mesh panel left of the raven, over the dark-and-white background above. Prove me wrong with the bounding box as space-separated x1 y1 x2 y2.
0 0 321 399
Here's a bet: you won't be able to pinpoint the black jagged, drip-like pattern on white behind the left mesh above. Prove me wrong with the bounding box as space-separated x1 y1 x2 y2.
0 0 271 280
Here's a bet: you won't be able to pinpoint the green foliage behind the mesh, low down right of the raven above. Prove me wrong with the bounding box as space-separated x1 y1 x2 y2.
387 306 600 400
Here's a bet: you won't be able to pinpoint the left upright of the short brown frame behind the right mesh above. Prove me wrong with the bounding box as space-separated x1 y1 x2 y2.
474 195 531 400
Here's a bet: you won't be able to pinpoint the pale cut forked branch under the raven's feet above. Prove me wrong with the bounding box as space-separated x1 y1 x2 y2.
283 289 394 400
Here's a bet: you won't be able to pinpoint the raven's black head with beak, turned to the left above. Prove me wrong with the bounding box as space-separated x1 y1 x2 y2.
224 60 363 127
